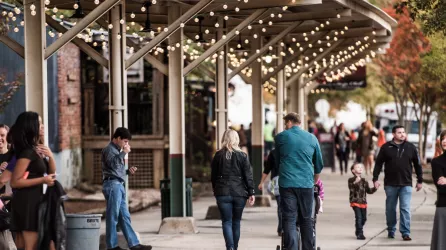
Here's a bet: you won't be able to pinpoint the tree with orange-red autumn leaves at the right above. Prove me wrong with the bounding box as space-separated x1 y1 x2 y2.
374 2 446 160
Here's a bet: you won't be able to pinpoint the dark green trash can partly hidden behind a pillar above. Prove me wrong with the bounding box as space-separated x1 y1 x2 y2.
160 178 193 219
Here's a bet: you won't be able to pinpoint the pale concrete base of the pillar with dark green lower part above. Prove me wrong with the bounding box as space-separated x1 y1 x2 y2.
158 217 198 234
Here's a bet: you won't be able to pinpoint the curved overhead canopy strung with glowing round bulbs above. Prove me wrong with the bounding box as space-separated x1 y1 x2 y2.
1 0 396 88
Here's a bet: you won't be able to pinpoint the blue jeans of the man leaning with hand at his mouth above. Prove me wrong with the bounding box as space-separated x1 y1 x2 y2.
102 180 139 249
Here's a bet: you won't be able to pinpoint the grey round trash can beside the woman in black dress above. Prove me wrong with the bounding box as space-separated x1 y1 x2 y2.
66 214 102 250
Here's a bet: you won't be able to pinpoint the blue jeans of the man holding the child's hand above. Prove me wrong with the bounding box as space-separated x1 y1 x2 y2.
384 186 412 236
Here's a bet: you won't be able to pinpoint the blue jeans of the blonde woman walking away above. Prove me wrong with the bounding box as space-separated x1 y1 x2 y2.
216 196 246 250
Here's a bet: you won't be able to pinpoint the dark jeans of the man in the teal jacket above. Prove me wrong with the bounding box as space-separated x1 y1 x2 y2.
280 188 314 250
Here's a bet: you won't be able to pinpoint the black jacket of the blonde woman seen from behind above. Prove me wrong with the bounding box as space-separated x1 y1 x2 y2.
211 149 255 197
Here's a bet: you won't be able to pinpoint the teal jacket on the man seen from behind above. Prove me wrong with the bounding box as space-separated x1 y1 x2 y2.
275 126 324 188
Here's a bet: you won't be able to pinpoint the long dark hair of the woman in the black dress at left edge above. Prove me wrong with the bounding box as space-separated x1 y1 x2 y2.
10 111 40 155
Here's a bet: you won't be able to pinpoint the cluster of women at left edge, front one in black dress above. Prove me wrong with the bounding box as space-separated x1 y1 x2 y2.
0 112 66 250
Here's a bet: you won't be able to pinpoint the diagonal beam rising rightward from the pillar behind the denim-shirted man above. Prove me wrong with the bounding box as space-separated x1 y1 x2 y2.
125 0 214 68
